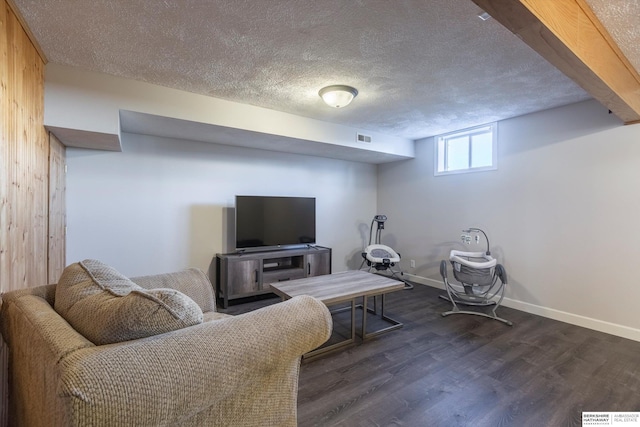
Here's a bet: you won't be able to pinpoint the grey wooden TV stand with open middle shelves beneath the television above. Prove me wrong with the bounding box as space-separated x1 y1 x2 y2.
215 246 331 308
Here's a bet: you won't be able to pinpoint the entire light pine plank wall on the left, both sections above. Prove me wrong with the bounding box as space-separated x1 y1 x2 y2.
0 0 65 426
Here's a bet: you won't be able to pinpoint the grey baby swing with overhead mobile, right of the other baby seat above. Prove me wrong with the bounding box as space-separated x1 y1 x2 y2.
440 228 513 326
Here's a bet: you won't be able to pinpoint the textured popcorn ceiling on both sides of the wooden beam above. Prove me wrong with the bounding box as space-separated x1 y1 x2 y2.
13 0 640 139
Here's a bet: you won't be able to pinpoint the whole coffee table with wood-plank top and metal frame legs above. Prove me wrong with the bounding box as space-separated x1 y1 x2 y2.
270 270 405 358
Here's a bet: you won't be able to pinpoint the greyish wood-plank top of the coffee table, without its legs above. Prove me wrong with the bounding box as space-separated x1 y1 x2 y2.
270 270 404 305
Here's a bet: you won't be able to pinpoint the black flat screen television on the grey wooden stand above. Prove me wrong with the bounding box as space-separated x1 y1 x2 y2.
235 196 316 251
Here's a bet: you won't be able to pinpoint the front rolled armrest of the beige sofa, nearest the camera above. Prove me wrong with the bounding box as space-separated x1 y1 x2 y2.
59 296 332 426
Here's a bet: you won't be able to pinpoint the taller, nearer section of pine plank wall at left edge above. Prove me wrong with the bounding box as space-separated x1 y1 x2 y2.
0 2 49 292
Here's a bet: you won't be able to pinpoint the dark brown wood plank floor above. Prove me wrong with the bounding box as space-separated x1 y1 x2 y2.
220 285 640 427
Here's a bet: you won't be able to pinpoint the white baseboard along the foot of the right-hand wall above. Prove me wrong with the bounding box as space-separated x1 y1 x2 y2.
404 273 640 342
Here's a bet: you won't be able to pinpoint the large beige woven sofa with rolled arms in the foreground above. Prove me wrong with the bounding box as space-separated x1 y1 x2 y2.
0 260 332 426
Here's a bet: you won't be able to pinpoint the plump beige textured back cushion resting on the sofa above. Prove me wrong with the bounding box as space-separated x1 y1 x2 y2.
54 260 203 345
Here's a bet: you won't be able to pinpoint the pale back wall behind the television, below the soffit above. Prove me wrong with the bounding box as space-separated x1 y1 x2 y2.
67 134 376 276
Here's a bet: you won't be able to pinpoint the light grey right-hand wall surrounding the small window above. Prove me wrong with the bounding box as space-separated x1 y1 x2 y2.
378 101 640 340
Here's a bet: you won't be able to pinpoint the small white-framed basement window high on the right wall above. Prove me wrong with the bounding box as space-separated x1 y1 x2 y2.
434 123 498 176
